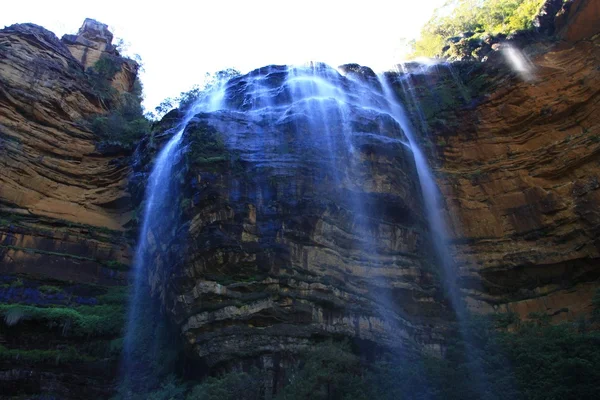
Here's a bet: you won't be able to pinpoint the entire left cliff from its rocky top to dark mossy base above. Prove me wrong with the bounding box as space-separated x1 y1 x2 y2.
0 21 136 398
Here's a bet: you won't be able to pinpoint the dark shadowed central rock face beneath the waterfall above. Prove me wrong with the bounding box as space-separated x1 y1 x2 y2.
142 66 451 374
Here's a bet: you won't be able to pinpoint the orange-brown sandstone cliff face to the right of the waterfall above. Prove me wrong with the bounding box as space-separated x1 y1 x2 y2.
400 1 600 321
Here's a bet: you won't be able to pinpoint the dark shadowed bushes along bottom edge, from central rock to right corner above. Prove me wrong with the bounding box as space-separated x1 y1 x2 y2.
138 306 600 400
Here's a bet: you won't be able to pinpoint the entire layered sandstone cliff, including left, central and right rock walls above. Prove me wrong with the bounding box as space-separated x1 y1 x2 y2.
0 0 600 398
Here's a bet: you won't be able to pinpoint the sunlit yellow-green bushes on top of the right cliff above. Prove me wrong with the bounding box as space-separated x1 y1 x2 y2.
412 0 545 57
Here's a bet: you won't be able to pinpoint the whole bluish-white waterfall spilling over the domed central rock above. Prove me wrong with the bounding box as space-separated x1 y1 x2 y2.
118 64 488 391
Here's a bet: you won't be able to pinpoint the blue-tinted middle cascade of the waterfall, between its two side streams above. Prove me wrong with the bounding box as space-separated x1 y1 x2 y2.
192 63 440 347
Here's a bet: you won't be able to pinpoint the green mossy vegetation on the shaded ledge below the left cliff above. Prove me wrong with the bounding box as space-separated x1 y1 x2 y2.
0 276 128 380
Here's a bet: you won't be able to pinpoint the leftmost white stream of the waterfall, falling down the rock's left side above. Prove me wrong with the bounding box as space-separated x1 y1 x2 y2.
121 92 222 392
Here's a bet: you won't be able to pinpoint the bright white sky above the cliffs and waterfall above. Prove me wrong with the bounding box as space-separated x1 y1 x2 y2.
0 0 445 111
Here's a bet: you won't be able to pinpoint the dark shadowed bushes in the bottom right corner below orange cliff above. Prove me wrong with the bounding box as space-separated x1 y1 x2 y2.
371 315 600 399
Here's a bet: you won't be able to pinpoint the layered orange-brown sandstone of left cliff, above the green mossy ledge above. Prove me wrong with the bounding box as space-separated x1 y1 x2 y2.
0 20 129 281
